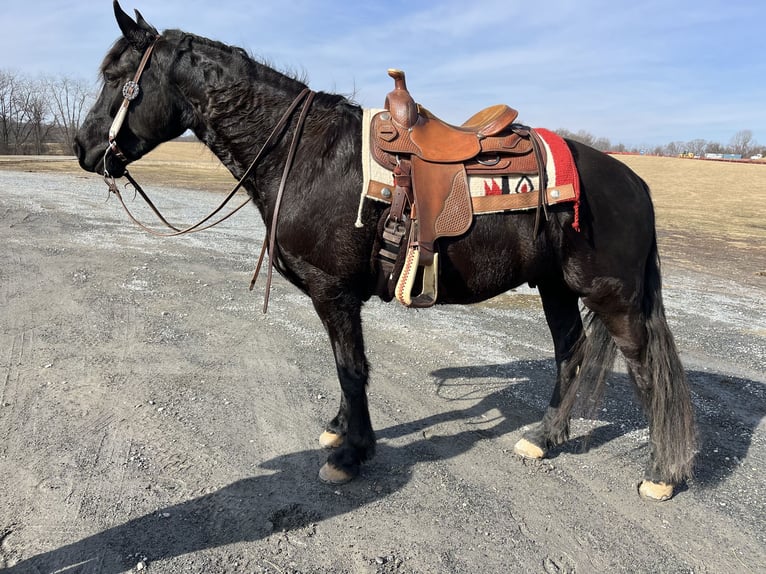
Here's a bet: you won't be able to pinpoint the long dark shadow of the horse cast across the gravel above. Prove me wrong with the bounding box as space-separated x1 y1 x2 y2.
3 360 766 574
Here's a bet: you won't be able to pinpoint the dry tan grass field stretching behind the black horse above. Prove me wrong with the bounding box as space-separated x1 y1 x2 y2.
0 142 766 284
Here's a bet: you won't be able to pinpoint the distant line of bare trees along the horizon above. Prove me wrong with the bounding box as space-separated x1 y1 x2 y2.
0 69 766 158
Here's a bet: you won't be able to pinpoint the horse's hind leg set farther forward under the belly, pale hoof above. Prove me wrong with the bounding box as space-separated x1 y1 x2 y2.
514 284 584 458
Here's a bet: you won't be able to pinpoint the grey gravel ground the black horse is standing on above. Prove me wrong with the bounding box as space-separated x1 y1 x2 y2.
0 171 766 574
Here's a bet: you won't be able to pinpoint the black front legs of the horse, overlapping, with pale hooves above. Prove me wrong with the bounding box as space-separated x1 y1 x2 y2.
312 293 375 484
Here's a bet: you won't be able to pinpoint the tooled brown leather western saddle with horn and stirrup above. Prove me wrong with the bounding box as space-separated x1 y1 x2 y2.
370 70 546 307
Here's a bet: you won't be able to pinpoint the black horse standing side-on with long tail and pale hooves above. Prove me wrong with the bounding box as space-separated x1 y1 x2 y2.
75 0 696 500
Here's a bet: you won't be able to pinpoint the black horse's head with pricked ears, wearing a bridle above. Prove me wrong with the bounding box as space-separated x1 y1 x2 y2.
74 0 188 177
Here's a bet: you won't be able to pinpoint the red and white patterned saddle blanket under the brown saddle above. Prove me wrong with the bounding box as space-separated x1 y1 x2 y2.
357 109 580 229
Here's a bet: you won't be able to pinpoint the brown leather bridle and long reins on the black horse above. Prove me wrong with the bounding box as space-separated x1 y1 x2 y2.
104 36 316 313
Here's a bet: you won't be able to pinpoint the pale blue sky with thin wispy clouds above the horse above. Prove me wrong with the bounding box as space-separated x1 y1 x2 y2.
0 0 766 146
